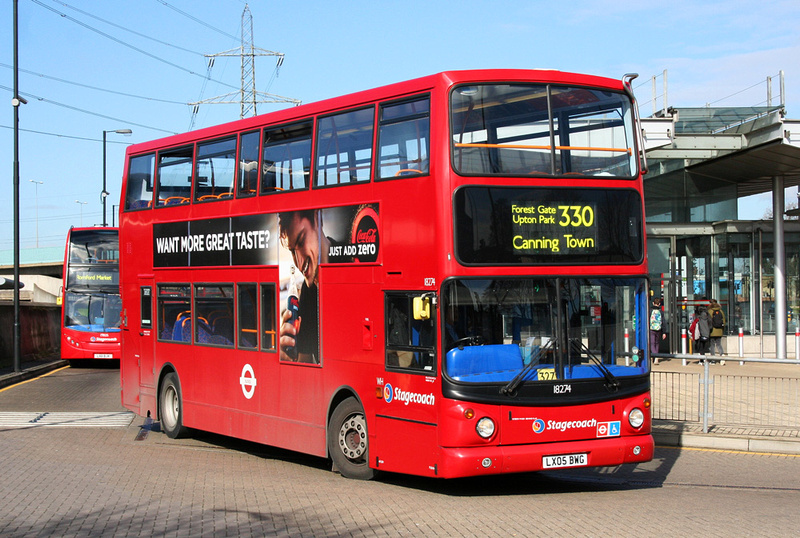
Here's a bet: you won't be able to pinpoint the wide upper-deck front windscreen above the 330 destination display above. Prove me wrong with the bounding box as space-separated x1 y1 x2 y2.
450 84 636 178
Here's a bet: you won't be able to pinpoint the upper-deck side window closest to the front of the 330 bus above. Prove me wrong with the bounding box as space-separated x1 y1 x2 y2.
378 97 430 179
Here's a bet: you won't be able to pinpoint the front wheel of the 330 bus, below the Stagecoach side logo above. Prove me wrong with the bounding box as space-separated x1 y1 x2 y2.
328 397 375 480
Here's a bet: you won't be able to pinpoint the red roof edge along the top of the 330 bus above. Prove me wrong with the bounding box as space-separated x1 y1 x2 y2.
127 69 623 155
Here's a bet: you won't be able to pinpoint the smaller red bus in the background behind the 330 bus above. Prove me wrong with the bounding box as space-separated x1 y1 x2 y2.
61 224 122 364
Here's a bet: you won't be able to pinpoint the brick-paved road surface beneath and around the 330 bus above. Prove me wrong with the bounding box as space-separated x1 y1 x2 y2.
0 362 800 538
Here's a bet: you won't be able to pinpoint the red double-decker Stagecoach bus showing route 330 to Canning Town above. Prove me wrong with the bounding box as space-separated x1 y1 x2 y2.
120 70 653 479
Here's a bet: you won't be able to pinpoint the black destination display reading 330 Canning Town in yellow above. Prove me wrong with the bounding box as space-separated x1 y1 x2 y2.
454 187 644 265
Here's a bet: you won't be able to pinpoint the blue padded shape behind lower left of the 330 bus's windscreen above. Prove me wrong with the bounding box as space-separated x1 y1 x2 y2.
446 344 522 382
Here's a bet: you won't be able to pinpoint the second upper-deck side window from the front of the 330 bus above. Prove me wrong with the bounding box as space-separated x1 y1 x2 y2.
315 107 375 187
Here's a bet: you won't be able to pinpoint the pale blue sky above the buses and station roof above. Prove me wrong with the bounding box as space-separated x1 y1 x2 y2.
0 0 800 250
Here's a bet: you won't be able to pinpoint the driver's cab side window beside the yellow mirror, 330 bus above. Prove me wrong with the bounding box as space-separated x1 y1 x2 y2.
385 293 436 372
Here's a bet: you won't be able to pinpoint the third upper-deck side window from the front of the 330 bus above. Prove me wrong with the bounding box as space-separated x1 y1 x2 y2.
261 121 313 194
